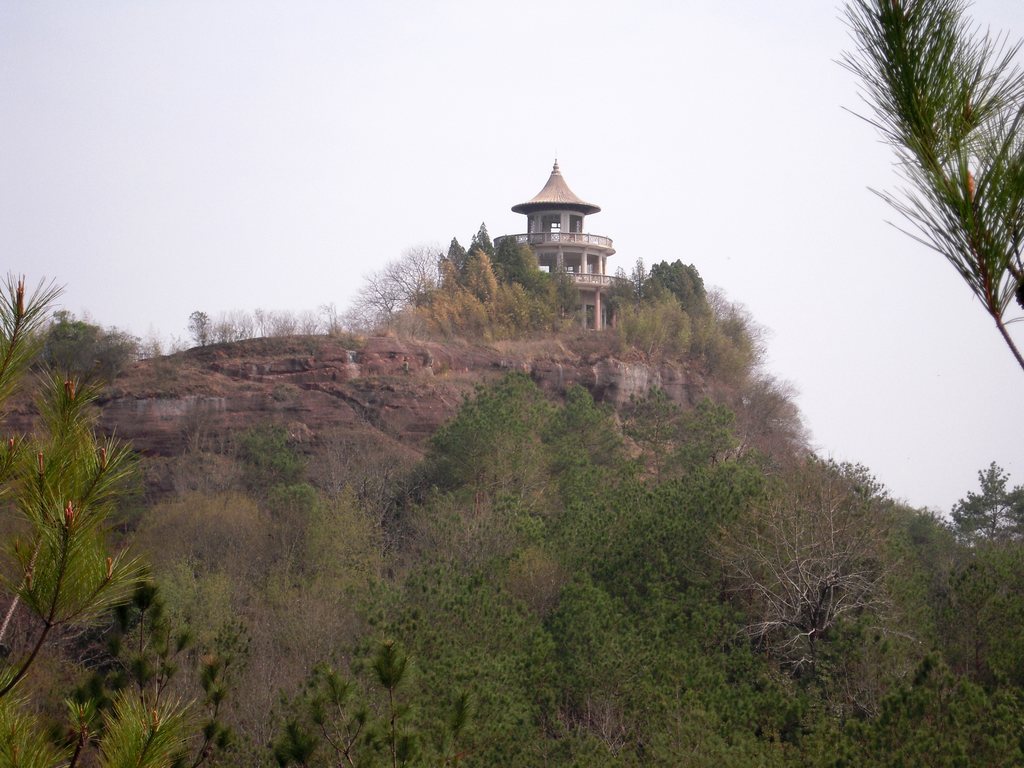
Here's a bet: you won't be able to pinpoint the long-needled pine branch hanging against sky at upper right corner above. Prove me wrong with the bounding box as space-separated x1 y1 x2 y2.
843 0 1024 369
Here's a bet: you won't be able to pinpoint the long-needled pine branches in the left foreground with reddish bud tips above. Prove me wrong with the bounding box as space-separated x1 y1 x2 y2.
0 279 187 768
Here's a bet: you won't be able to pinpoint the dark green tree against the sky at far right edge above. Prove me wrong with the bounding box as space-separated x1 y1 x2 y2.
952 462 1024 542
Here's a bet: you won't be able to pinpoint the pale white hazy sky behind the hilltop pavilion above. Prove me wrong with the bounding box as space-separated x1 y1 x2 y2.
0 0 1024 512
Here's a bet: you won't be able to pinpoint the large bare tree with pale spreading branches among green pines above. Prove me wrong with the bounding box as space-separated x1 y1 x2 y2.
718 460 891 672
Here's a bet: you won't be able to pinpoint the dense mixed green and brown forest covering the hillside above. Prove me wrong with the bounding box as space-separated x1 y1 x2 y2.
6 227 1024 766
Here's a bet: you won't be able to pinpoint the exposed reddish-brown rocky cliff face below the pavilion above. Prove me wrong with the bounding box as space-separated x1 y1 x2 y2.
2 337 707 456
